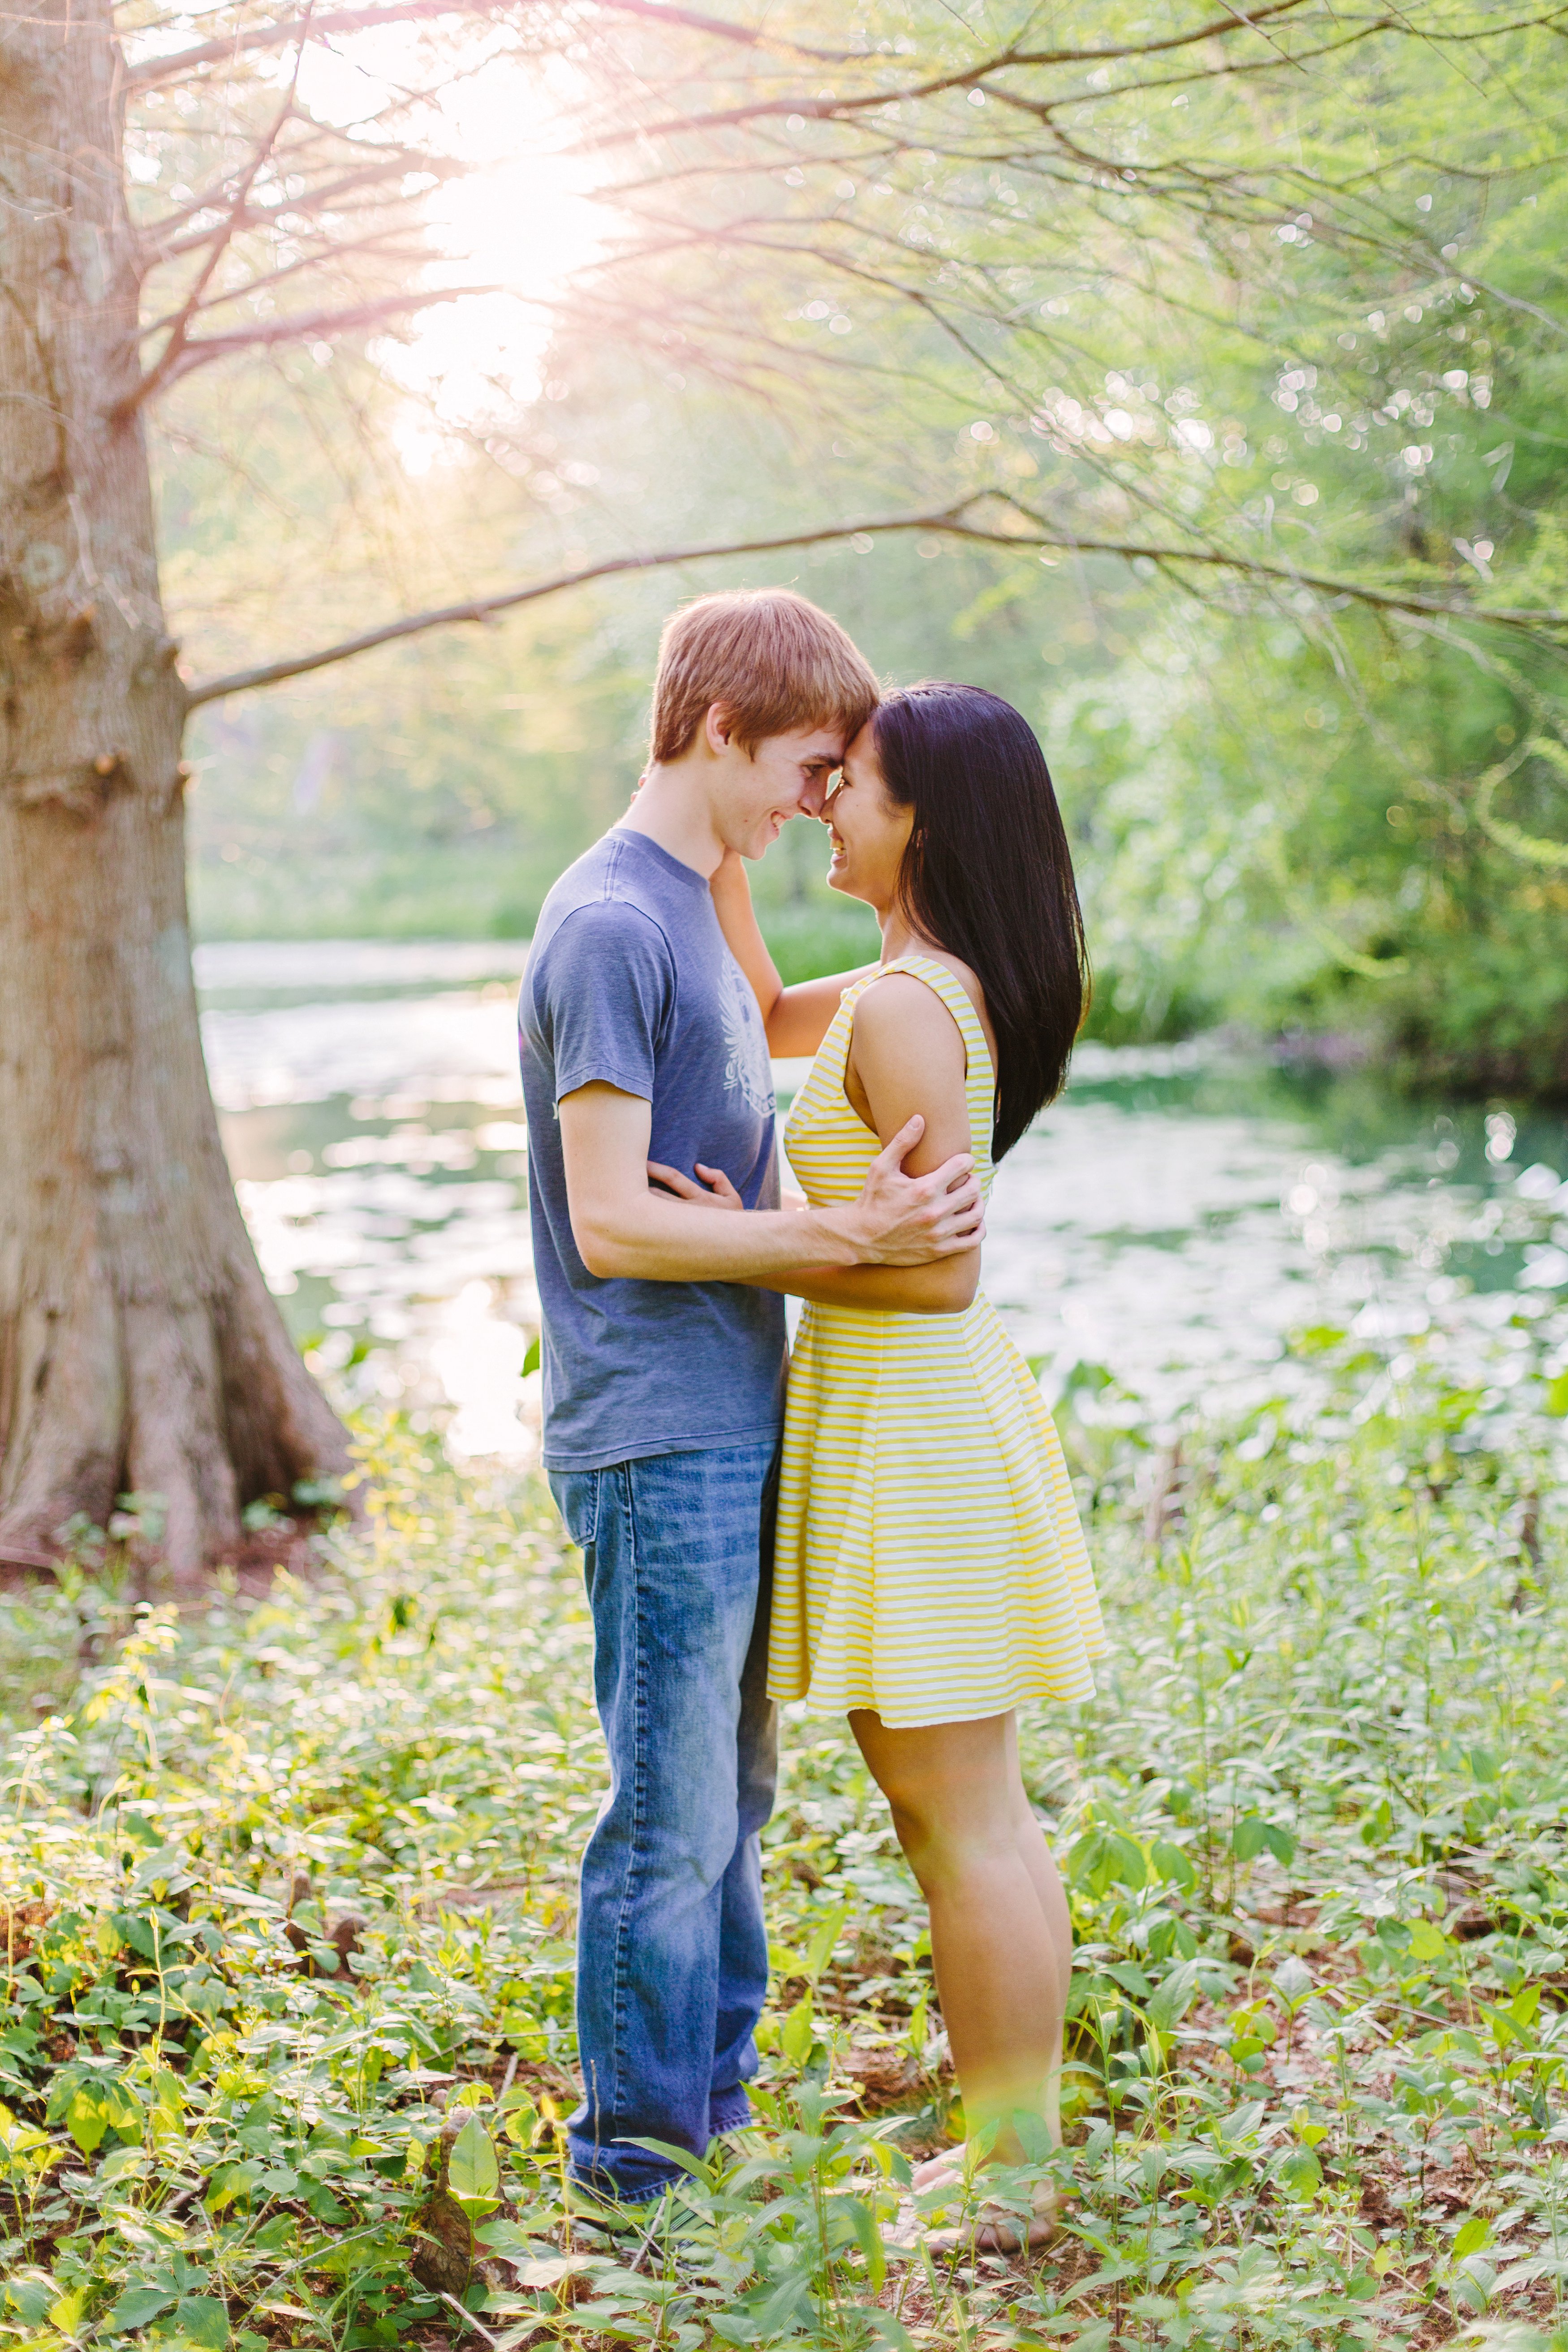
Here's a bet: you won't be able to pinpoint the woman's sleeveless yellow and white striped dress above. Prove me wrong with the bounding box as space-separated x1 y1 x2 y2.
769 955 1107 1729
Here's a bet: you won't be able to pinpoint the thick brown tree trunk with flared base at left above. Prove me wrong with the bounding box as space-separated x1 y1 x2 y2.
0 0 345 1581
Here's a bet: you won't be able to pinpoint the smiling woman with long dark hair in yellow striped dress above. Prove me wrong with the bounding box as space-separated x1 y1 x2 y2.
658 685 1105 2246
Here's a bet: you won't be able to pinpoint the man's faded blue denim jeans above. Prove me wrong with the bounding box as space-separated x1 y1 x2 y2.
550 1442 778 2201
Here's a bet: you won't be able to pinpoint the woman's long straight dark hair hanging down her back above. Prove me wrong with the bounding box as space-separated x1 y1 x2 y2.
872 680 1089 1159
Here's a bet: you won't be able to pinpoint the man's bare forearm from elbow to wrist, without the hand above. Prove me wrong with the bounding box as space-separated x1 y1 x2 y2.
571 1190 861 1282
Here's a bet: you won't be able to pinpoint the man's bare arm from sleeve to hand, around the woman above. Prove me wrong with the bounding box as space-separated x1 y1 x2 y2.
560 1082 980 1282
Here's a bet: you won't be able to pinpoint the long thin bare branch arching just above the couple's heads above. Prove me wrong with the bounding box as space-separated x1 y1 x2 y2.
186 489 1568 711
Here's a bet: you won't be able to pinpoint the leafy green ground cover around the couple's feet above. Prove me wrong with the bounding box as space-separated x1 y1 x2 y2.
0 1317 1568 2352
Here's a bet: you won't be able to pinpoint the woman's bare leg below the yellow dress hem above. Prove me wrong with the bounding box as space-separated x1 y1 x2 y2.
849 1710 1072 2164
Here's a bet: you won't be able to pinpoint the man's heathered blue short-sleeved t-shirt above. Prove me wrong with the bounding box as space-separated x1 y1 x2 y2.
517 830 785 1470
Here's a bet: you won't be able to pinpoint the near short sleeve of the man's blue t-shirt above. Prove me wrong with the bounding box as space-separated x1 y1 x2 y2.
534 899 675 1103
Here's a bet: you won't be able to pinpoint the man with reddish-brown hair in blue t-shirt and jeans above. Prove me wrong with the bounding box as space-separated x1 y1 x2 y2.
520 590 980 2204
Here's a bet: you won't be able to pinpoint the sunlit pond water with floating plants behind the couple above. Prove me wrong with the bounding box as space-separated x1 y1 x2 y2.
198 941 1568 1458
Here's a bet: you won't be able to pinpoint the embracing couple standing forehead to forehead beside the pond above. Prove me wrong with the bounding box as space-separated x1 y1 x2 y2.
520 590 1105 2244
